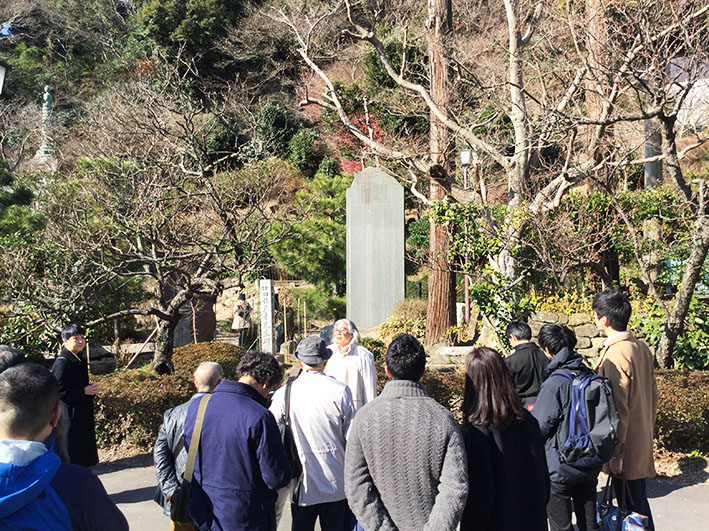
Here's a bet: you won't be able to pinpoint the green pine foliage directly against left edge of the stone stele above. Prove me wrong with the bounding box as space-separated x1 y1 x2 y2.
271 173 352 294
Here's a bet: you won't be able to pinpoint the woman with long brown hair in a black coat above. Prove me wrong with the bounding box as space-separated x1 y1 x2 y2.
460 347 549 531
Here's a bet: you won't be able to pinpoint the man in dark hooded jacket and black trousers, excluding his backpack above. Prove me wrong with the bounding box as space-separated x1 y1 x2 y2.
532 323 602 531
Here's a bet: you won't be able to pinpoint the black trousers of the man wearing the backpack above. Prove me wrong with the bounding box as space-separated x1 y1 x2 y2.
547 478 598 531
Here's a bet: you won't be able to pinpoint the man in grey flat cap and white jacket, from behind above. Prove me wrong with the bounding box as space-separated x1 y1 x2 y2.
270 336 355 531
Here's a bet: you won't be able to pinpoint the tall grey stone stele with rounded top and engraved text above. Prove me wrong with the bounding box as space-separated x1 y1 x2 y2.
347 167 405 329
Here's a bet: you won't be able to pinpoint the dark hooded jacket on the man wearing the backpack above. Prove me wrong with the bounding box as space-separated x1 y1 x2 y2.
532 347 601 485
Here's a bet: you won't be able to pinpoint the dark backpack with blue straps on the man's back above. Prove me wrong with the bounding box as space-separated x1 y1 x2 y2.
554 370 618 469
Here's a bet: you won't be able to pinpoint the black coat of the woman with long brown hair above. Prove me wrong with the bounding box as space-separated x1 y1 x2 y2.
460 411 549 531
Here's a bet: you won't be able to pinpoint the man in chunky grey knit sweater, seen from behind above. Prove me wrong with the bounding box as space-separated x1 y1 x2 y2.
345 334 468 531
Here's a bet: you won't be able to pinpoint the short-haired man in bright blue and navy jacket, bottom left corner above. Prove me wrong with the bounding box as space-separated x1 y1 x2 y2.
0 363 128 531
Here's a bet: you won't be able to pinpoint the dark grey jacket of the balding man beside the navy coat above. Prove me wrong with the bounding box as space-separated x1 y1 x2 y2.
153 393 204 516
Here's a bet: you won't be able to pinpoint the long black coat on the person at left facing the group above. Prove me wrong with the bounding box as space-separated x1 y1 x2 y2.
52 348 98 466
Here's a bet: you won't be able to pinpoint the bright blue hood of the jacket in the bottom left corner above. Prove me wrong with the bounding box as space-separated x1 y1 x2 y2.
0 451 61 520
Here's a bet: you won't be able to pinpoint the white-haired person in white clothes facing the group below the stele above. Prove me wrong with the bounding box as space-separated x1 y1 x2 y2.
325 319 377 411
